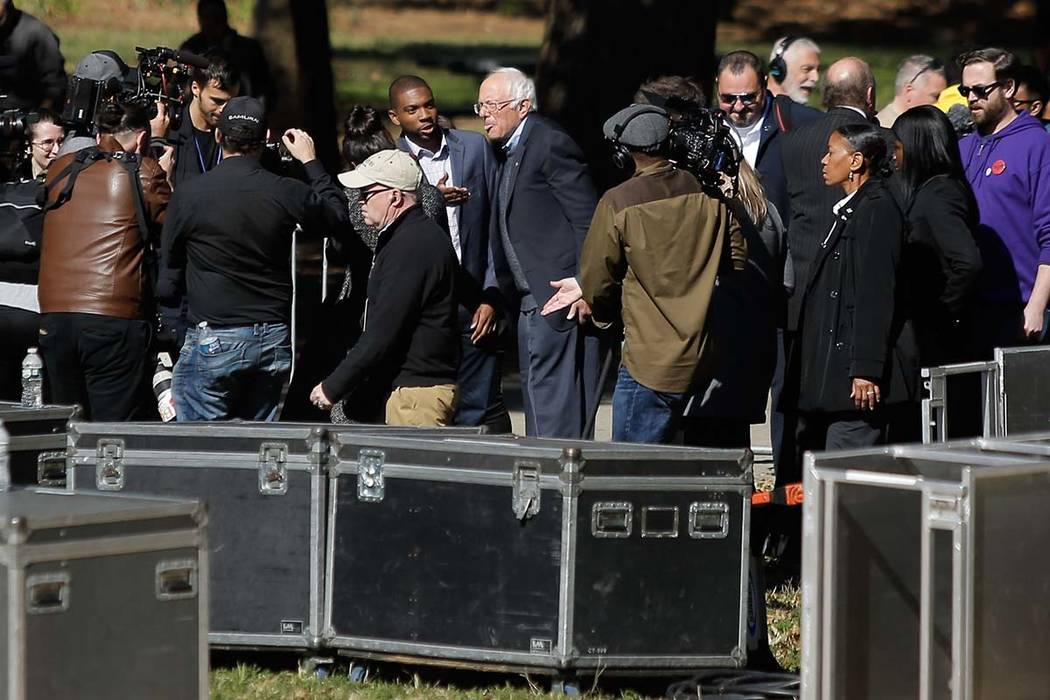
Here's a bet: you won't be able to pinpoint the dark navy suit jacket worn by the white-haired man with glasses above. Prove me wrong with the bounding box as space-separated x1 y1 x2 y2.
491 112 597 331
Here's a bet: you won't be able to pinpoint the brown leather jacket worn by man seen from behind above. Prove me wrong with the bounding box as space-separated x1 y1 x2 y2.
38 136 171 318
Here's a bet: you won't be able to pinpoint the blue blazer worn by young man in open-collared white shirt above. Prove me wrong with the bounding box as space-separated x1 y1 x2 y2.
398 129 499 314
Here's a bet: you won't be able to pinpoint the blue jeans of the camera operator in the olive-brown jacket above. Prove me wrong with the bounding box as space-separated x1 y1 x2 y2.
612 365 689 444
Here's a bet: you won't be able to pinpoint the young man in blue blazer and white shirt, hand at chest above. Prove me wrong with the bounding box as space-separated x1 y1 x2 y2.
389 76 510 432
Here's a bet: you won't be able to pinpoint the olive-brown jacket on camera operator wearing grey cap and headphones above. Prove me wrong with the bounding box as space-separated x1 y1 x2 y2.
580 161 748 391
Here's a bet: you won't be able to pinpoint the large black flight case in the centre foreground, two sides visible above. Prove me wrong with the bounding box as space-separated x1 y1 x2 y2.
324 430 753 678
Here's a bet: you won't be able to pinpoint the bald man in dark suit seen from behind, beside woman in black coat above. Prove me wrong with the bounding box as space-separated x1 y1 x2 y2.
773 57 875 485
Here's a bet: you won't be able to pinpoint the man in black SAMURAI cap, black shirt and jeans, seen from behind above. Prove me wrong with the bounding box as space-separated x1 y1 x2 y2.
160 98 349 421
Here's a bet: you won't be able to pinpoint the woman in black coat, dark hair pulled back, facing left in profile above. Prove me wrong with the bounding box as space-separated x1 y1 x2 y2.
793 124 919 450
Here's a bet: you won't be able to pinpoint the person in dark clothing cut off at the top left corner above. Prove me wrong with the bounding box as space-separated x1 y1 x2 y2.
0 0 66 109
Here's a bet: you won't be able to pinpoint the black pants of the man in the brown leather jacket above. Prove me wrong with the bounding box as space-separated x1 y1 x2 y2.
40 314 151 421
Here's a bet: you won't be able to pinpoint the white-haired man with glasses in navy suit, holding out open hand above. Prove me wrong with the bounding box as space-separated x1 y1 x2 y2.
475 68 599 438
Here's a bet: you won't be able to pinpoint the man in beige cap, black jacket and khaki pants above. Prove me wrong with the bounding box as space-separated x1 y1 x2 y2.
310 150 460 426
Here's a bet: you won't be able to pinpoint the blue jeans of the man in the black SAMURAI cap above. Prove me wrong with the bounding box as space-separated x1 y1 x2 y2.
171 323 292 421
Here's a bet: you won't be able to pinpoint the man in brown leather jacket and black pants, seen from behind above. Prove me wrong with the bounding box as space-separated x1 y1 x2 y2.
39 100 171 421
